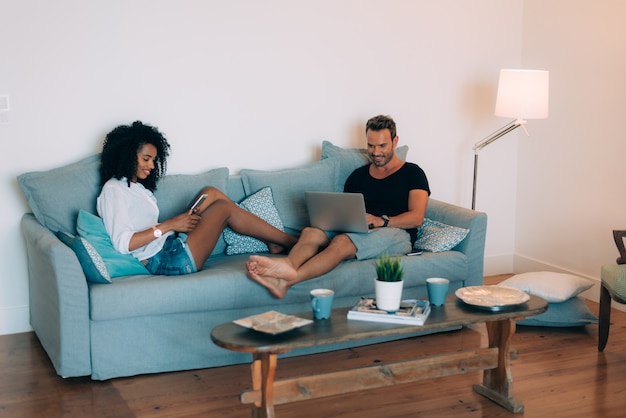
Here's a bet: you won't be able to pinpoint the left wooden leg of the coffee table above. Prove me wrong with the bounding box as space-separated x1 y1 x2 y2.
251 353 277 418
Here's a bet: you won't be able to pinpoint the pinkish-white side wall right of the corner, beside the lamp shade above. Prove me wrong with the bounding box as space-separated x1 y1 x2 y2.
515 0 626 306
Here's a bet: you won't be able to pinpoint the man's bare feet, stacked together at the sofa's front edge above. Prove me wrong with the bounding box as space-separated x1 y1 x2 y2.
246 255 297 299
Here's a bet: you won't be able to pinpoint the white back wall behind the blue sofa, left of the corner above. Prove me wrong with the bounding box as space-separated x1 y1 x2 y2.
0 0 520 334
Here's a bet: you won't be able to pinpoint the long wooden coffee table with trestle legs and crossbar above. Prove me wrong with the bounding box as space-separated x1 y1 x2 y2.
211 295 548 417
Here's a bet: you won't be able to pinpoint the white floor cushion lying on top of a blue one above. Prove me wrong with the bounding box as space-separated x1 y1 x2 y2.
500 271 593 303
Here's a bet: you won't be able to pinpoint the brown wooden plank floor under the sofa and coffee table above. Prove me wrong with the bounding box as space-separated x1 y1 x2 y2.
0 276 626 418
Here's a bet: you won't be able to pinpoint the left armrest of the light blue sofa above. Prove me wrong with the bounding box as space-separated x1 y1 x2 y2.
20 213 91 377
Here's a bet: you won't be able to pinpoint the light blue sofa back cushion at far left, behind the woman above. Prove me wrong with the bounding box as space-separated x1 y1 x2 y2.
17 154 100 234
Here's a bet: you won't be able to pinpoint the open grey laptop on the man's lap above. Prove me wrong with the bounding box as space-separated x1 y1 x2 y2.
304 191 370 233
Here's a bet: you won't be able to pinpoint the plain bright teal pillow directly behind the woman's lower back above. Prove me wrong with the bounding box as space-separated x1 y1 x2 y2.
76 210 150 279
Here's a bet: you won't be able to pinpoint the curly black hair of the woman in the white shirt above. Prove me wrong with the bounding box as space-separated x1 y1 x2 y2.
100 121 170 191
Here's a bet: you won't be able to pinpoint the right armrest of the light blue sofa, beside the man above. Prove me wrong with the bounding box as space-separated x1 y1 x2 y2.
426 199 487 286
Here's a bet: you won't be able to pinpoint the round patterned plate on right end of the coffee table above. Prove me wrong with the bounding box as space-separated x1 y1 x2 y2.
455 286 530 311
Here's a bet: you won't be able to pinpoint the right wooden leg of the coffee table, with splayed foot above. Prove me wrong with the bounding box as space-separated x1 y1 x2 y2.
473 319 524 414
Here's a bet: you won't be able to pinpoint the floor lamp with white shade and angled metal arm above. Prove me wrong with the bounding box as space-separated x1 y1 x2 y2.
472 70 549 210
